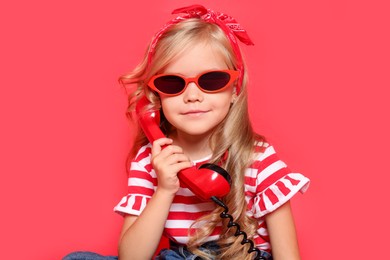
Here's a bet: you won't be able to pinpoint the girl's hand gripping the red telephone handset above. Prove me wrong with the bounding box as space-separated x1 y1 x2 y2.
152 138 192 195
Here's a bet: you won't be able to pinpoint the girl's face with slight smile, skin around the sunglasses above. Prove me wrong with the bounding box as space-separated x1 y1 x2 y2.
160 44 235 140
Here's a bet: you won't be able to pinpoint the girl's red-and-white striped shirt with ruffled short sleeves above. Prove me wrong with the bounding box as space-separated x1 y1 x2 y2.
114 143 310 251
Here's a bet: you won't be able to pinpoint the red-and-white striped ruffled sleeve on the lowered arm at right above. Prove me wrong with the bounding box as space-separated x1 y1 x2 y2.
245 145 310 218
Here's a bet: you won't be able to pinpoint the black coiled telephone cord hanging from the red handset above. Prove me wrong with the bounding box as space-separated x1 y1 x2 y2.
211 196 265 260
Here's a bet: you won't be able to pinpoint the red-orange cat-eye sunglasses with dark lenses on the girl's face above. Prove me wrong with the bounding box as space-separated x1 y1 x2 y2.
148 70 239 96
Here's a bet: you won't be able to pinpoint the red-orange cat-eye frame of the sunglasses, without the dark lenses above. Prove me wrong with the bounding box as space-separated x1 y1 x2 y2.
148 70 240 96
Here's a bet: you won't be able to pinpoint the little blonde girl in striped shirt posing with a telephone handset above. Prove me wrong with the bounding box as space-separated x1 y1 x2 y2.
64 5 309 260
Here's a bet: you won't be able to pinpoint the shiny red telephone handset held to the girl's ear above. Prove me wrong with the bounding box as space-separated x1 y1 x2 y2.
135 96 230 200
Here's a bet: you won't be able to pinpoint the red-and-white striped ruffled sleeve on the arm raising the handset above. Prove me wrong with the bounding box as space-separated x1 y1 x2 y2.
114 146 157 216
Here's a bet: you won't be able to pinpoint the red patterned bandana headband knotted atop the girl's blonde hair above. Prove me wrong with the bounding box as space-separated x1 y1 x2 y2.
148 5 253 94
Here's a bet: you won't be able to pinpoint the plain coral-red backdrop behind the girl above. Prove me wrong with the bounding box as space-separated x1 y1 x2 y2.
0 0 390 260
